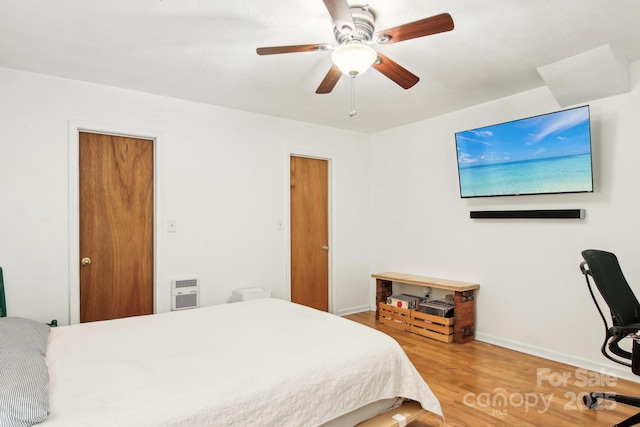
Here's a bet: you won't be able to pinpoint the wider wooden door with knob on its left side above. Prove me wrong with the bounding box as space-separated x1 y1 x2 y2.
78 132 153 322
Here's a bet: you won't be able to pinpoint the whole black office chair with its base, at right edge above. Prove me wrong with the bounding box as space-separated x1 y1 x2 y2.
580 249 640 427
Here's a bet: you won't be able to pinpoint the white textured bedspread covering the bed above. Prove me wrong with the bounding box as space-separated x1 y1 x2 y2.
44 299 442 427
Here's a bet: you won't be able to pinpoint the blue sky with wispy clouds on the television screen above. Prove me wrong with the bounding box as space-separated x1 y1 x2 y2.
456 106 591 167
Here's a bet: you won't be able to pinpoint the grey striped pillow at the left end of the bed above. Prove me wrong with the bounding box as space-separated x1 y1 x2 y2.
0 317 49 427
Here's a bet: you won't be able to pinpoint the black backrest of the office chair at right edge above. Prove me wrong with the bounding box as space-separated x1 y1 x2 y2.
582 249 640 325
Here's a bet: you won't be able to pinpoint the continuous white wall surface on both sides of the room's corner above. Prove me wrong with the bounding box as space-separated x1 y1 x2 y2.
5 57 640 382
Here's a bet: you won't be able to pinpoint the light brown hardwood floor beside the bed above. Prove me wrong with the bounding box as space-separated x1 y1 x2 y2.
345 312 640 427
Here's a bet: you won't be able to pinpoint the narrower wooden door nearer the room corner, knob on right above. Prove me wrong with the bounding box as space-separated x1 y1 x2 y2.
290 156 329 311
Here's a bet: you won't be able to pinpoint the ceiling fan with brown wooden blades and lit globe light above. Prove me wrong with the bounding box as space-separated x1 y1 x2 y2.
256 0 453 96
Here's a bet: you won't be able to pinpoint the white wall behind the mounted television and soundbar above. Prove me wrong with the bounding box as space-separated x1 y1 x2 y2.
370 63 640 382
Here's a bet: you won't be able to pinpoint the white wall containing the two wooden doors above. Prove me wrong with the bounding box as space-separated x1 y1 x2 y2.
0 69 369 324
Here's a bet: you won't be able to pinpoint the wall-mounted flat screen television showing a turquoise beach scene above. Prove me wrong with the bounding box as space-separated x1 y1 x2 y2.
455 105 593 198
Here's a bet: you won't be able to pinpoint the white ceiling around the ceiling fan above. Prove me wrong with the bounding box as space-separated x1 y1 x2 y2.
0 0 640 133
